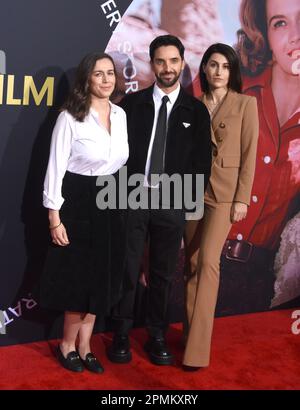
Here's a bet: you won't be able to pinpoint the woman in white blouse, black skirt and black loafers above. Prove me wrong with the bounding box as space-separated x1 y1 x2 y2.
40 53 128 373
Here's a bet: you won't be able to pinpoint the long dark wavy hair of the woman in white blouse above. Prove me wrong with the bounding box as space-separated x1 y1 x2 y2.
62 52 117 122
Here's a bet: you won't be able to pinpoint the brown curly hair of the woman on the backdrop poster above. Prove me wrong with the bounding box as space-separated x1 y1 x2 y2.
235 0 272 75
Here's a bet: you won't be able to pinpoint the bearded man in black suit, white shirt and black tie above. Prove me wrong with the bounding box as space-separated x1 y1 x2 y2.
108 35 211 365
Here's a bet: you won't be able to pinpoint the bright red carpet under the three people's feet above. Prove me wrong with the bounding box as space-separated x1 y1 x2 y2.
0 310 300 390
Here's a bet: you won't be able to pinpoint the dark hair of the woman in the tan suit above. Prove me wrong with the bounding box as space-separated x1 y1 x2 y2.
199 43 242 93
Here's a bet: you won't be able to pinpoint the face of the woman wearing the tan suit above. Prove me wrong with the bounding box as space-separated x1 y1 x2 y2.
203 53 230 90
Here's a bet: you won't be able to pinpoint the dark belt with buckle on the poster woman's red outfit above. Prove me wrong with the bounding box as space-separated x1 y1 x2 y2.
222 239 274 263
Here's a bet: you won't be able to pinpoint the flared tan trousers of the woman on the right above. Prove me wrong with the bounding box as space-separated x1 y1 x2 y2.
183 187 232 367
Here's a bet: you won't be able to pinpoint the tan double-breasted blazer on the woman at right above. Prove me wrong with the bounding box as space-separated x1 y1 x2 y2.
201 91 259 205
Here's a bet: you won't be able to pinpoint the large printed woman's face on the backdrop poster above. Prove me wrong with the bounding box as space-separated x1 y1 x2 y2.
266 0 300 75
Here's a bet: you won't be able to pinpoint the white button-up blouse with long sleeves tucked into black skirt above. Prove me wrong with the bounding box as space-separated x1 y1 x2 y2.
43 103 129 210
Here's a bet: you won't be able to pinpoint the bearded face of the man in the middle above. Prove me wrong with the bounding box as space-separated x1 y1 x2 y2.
151 46 184 89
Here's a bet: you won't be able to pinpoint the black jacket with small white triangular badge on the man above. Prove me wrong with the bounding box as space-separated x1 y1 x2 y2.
120 85 211 207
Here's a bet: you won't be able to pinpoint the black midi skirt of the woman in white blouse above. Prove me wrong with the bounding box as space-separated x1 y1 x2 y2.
39 172 126 316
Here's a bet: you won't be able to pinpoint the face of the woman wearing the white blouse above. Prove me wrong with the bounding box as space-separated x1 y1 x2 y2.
89 58 116 98
